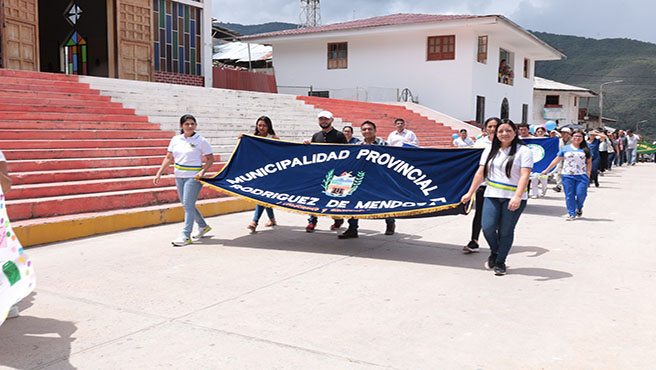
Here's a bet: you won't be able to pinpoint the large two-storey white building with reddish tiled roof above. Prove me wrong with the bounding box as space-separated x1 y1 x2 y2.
244 14 565 122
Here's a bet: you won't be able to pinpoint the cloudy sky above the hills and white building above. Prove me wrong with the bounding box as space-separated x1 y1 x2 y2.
212 0 656 43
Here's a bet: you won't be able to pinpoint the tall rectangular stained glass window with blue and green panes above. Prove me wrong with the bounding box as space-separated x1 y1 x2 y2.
153 0 203 76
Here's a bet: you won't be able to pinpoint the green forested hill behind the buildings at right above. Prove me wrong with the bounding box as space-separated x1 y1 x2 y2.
532 32 656 140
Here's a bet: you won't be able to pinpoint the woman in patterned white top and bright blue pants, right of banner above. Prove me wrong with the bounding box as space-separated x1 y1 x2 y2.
542 131 592 221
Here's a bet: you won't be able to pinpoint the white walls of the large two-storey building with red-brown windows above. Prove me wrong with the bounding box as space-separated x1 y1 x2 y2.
273 26 534 122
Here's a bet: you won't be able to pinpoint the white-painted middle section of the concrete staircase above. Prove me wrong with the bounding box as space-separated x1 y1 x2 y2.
80 76 334 161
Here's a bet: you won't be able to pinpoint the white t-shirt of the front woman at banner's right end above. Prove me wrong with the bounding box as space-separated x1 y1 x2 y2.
480 145 533 199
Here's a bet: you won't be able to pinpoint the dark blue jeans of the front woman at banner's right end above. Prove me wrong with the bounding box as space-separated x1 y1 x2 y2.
482 198 526 263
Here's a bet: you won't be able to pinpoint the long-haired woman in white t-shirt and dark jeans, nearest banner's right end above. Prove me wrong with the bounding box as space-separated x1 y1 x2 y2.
461 119 533 275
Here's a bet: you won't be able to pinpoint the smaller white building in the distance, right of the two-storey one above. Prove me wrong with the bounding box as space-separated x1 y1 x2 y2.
530 76 597 127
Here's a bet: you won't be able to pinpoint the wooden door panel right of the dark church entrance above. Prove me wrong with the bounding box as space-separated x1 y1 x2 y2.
116 0 153 81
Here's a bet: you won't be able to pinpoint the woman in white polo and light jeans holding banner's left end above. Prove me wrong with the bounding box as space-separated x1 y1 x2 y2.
153 114 214 247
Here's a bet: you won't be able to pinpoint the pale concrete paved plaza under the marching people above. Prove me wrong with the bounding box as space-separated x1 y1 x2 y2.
0 163 656 370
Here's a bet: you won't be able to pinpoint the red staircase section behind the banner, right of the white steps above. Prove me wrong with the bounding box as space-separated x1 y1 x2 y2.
298 96 457 147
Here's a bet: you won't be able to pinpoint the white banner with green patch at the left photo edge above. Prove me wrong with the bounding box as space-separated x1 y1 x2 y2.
0 190 36 325
